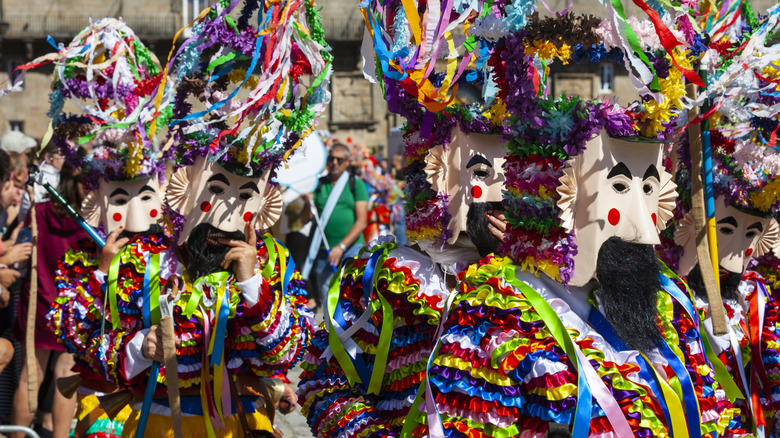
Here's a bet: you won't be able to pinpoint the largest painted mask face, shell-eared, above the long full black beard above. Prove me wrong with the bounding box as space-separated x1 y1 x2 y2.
558 132 676 286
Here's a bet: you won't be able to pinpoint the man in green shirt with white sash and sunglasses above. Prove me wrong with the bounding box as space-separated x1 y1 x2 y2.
301 143 368 307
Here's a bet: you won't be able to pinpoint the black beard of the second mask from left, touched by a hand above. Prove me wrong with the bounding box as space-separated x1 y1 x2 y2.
187 224 245 281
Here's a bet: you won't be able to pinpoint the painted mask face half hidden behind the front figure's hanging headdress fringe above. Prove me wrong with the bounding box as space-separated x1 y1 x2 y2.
425 127 506 243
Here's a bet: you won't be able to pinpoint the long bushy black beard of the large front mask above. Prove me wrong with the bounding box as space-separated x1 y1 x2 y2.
596 237 661 351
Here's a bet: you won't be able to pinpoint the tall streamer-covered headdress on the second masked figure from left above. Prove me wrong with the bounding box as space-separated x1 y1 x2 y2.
167 0 331 176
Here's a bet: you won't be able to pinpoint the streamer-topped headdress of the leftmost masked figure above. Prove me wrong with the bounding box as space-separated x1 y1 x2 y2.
2 18 169 188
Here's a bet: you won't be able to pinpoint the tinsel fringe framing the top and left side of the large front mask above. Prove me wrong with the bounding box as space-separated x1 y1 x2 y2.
499 98 639 283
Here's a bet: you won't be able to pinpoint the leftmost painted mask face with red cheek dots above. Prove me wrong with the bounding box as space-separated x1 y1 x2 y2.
82 176 163 234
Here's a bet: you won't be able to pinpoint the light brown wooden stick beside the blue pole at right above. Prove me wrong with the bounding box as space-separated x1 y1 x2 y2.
686 84 728 336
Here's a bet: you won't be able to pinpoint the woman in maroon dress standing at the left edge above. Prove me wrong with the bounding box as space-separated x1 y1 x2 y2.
12 162 87 438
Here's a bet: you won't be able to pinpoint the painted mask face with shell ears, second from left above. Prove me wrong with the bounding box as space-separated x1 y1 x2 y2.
166 157 282 244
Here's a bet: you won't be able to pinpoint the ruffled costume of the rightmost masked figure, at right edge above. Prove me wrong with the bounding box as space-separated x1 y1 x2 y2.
696 271 780 432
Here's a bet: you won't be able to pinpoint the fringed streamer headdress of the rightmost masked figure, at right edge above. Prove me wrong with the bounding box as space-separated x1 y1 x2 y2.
661 2 780 267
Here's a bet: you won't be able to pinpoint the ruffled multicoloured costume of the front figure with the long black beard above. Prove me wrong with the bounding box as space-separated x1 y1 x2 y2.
420 256 745 437
